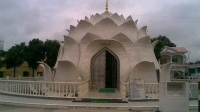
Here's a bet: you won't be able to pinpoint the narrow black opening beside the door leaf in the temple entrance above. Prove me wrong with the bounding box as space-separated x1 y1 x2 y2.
105 51 117 88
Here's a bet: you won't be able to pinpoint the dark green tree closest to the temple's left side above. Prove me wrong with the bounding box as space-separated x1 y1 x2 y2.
44 40 60 68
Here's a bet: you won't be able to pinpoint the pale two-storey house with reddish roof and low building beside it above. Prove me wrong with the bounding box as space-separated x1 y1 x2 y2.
160 46 200 80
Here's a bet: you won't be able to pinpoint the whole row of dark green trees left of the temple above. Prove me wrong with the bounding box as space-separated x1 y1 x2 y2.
0 39 60 76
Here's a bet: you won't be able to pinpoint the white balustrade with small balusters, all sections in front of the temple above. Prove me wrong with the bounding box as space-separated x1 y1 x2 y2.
0 80 198 99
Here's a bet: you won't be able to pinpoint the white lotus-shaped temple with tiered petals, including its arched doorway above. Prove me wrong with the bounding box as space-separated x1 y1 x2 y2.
48 12 160 88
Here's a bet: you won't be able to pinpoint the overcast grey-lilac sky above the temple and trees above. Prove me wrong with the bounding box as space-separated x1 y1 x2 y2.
0 0 200 61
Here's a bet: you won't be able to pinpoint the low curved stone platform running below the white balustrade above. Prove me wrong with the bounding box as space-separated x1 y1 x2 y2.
0 94 198 112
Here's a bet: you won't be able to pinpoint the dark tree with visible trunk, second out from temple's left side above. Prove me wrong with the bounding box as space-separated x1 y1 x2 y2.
25 39 45 77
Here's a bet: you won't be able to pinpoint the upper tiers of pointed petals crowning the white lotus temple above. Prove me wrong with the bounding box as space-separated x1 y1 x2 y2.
69 12 142 43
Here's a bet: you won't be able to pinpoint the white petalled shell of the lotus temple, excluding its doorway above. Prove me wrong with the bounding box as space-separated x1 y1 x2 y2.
55 11 160 83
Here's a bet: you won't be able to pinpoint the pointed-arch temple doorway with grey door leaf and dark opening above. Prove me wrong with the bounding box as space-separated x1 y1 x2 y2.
91 48 119 89
